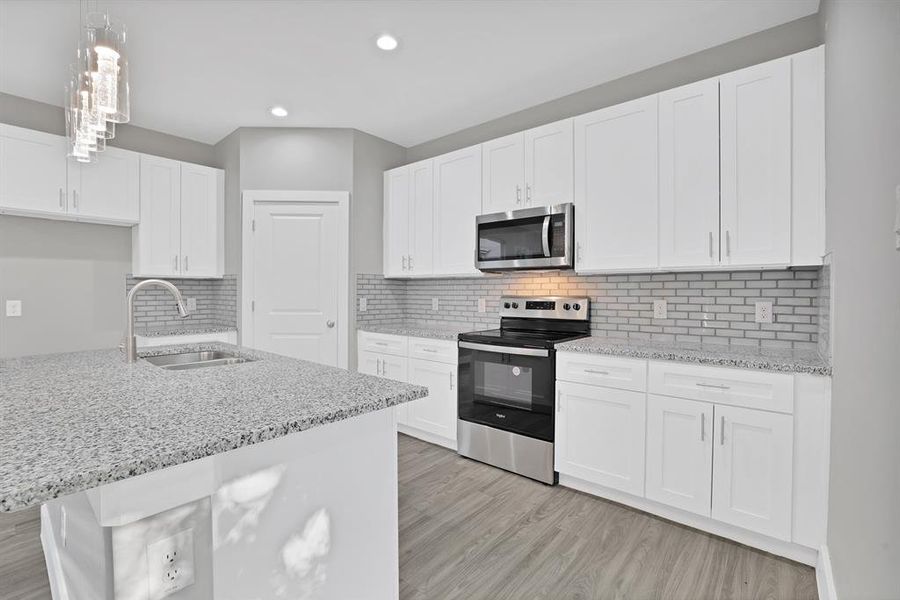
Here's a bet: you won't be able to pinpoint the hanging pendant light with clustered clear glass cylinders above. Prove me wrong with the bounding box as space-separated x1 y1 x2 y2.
65 0 131 162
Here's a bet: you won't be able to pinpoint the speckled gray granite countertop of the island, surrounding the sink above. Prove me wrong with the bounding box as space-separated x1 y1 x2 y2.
0 343 427 512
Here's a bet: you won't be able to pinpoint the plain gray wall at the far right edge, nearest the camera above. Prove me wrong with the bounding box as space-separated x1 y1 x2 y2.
823 0 900 600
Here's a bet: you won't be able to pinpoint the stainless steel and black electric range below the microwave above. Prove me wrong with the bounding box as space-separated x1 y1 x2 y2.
456 296 590 485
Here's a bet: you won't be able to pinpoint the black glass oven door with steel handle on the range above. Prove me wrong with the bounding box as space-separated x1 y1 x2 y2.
458 341 556 442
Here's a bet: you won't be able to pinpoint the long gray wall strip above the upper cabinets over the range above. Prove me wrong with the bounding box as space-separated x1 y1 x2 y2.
407 15 822 162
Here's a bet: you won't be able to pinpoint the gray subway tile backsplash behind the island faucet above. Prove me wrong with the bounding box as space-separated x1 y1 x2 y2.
125 275 237 330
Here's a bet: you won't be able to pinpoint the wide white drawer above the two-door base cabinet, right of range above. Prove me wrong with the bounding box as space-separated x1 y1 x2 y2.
648 361 794 413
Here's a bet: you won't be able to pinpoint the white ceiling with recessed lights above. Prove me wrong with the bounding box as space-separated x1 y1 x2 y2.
0 0 819 146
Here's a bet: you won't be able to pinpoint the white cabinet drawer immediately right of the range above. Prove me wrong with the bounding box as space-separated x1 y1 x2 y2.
556 352 647 392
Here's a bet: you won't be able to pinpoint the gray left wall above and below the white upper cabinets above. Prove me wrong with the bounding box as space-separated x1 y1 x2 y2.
0 94 217 357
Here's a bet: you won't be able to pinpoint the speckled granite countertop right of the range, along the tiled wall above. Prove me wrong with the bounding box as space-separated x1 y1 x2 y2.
556 336 831 375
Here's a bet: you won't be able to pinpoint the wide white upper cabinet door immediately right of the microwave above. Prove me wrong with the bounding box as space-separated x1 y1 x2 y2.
575 95 659 271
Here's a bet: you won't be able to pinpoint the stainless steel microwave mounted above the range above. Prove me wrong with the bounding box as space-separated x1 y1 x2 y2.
475 203 575 271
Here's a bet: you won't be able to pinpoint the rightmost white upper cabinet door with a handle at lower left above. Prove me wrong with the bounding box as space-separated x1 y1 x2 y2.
719 56 791 265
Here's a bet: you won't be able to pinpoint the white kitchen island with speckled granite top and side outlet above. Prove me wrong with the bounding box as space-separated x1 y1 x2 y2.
0 343 427 600
